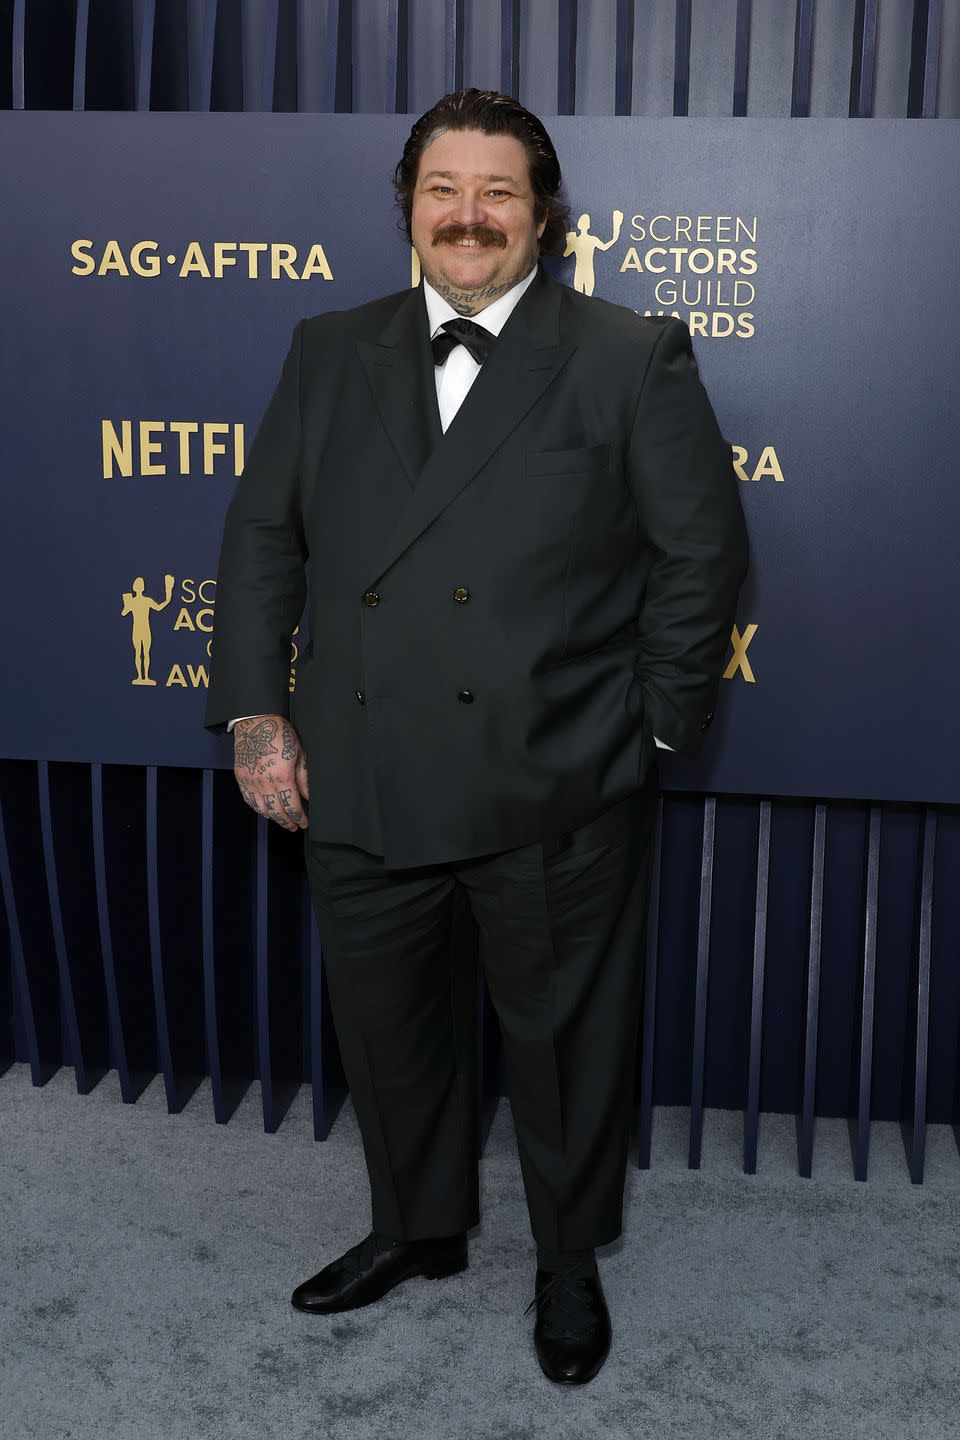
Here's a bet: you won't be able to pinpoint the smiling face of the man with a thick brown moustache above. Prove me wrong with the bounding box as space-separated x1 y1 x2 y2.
410 130 547 315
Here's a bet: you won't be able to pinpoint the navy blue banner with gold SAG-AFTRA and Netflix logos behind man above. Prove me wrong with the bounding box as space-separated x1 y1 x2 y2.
0 112 960 802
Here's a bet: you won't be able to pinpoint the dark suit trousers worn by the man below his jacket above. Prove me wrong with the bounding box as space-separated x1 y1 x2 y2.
305 778 656 1250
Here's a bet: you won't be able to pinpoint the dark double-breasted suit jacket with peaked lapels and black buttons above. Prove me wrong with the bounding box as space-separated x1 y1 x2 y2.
206 266 747 867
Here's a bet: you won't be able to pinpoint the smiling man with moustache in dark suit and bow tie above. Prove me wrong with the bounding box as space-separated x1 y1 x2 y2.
207 89 746 1384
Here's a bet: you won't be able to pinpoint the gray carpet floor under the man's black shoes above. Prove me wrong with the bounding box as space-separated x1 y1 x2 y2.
0 1066 960 1440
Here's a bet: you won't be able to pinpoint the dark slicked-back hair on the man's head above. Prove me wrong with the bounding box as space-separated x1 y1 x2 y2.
393 89 567 255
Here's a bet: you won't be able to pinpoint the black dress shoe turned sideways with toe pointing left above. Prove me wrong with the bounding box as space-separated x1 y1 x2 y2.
291 1231 466 1315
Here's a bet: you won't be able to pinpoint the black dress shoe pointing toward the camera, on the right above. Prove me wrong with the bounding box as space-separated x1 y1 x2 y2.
524 1264 612 1385
